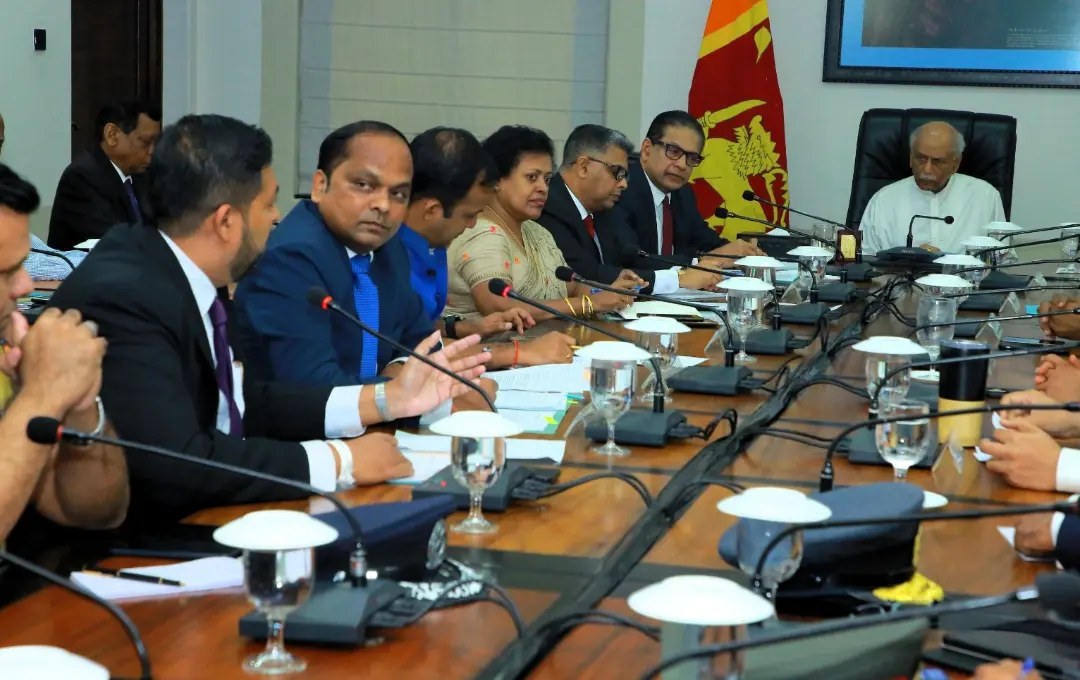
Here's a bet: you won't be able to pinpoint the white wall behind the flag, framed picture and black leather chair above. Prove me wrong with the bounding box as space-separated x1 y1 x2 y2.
630 0 1080 228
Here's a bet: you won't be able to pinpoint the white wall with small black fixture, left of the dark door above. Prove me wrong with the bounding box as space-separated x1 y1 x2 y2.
0 0 71 233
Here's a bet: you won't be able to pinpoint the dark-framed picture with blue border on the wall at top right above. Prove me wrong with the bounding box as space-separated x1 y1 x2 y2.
823 0 1080 87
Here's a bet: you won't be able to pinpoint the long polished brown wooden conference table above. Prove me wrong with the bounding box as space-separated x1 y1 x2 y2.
0 274 1061 680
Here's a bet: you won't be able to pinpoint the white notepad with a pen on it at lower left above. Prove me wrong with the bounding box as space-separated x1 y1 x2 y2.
71 557 244 600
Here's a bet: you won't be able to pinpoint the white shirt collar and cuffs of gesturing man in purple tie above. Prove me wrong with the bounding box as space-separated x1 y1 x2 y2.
161 233 364 491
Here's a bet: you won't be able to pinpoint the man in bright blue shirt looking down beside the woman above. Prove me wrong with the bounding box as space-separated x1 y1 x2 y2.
397 127 573 368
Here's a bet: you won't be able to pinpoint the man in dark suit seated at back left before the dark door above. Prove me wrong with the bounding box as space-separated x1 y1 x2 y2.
49 101 161 250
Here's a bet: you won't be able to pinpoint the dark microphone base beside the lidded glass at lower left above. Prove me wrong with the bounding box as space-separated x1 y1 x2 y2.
240 579 405 647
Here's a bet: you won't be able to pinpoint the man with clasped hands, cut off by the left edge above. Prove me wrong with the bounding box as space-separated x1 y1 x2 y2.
0 162 127 546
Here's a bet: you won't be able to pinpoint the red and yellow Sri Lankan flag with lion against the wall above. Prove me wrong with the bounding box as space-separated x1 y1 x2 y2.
688 0 789 239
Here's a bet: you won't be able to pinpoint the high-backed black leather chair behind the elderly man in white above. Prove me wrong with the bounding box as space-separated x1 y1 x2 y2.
848 109 1016 225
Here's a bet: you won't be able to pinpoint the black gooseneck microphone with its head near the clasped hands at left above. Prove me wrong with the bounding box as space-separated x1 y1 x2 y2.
26 417 367 585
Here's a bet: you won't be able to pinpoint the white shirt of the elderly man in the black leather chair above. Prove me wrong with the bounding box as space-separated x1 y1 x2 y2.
860 173 1005 255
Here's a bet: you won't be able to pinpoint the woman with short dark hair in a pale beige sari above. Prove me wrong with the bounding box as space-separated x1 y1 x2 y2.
447 125 633 321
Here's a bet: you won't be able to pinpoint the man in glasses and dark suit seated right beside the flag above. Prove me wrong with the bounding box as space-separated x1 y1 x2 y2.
597 111 764 269
